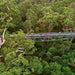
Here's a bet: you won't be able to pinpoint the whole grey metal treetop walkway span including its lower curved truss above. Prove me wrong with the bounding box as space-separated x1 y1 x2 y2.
25 32 75 42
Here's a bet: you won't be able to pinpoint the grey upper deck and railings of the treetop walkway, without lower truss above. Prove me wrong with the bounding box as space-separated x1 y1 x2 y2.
25 33 75 39
